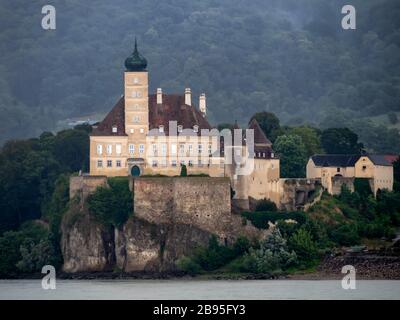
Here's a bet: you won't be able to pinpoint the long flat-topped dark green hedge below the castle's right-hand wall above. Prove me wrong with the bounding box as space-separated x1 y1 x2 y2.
242 211 306 229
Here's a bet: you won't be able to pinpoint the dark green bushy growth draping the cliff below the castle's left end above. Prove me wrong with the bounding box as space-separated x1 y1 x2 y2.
87 177 133 228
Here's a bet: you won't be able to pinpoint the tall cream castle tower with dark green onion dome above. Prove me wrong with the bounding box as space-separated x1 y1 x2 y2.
124 38 149 158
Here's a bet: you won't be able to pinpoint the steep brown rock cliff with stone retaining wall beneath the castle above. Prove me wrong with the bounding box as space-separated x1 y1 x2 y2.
61 178 266 272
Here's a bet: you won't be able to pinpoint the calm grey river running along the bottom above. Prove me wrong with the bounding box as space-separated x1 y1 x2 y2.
0 280 400 300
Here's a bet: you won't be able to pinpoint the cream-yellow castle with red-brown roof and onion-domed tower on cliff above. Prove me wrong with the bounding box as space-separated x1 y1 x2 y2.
90 40 280 203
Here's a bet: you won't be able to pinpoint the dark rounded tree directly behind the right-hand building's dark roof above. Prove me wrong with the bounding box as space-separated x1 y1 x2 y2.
321 128 363 154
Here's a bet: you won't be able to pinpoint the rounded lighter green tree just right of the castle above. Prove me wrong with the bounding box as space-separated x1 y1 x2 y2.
274 135 308 178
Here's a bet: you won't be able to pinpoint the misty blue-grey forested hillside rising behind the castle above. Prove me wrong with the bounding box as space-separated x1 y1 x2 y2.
0 0 400 152
